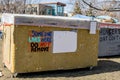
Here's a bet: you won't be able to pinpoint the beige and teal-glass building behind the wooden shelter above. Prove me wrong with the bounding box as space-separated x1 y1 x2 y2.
25 2 66 16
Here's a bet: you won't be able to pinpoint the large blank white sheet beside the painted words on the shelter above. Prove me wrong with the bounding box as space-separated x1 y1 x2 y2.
53 31 77 53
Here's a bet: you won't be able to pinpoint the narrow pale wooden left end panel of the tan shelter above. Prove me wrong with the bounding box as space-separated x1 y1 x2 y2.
2 26 15 72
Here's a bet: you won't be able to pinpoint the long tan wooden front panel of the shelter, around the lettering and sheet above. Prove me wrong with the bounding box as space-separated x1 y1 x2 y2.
14 26 99 73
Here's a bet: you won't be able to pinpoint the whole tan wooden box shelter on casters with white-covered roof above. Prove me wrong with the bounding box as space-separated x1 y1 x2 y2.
2 14 99 77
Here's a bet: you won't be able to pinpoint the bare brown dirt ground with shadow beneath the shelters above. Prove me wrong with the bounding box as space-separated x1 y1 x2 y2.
0 41 120 80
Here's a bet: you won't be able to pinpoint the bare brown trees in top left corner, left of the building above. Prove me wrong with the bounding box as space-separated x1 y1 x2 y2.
0 0 26 13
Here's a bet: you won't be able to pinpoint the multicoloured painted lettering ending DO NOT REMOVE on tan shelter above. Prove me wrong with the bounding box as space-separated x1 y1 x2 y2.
28 30 52 52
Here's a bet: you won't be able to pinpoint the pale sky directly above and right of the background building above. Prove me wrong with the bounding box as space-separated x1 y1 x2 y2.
27 0 73 12
